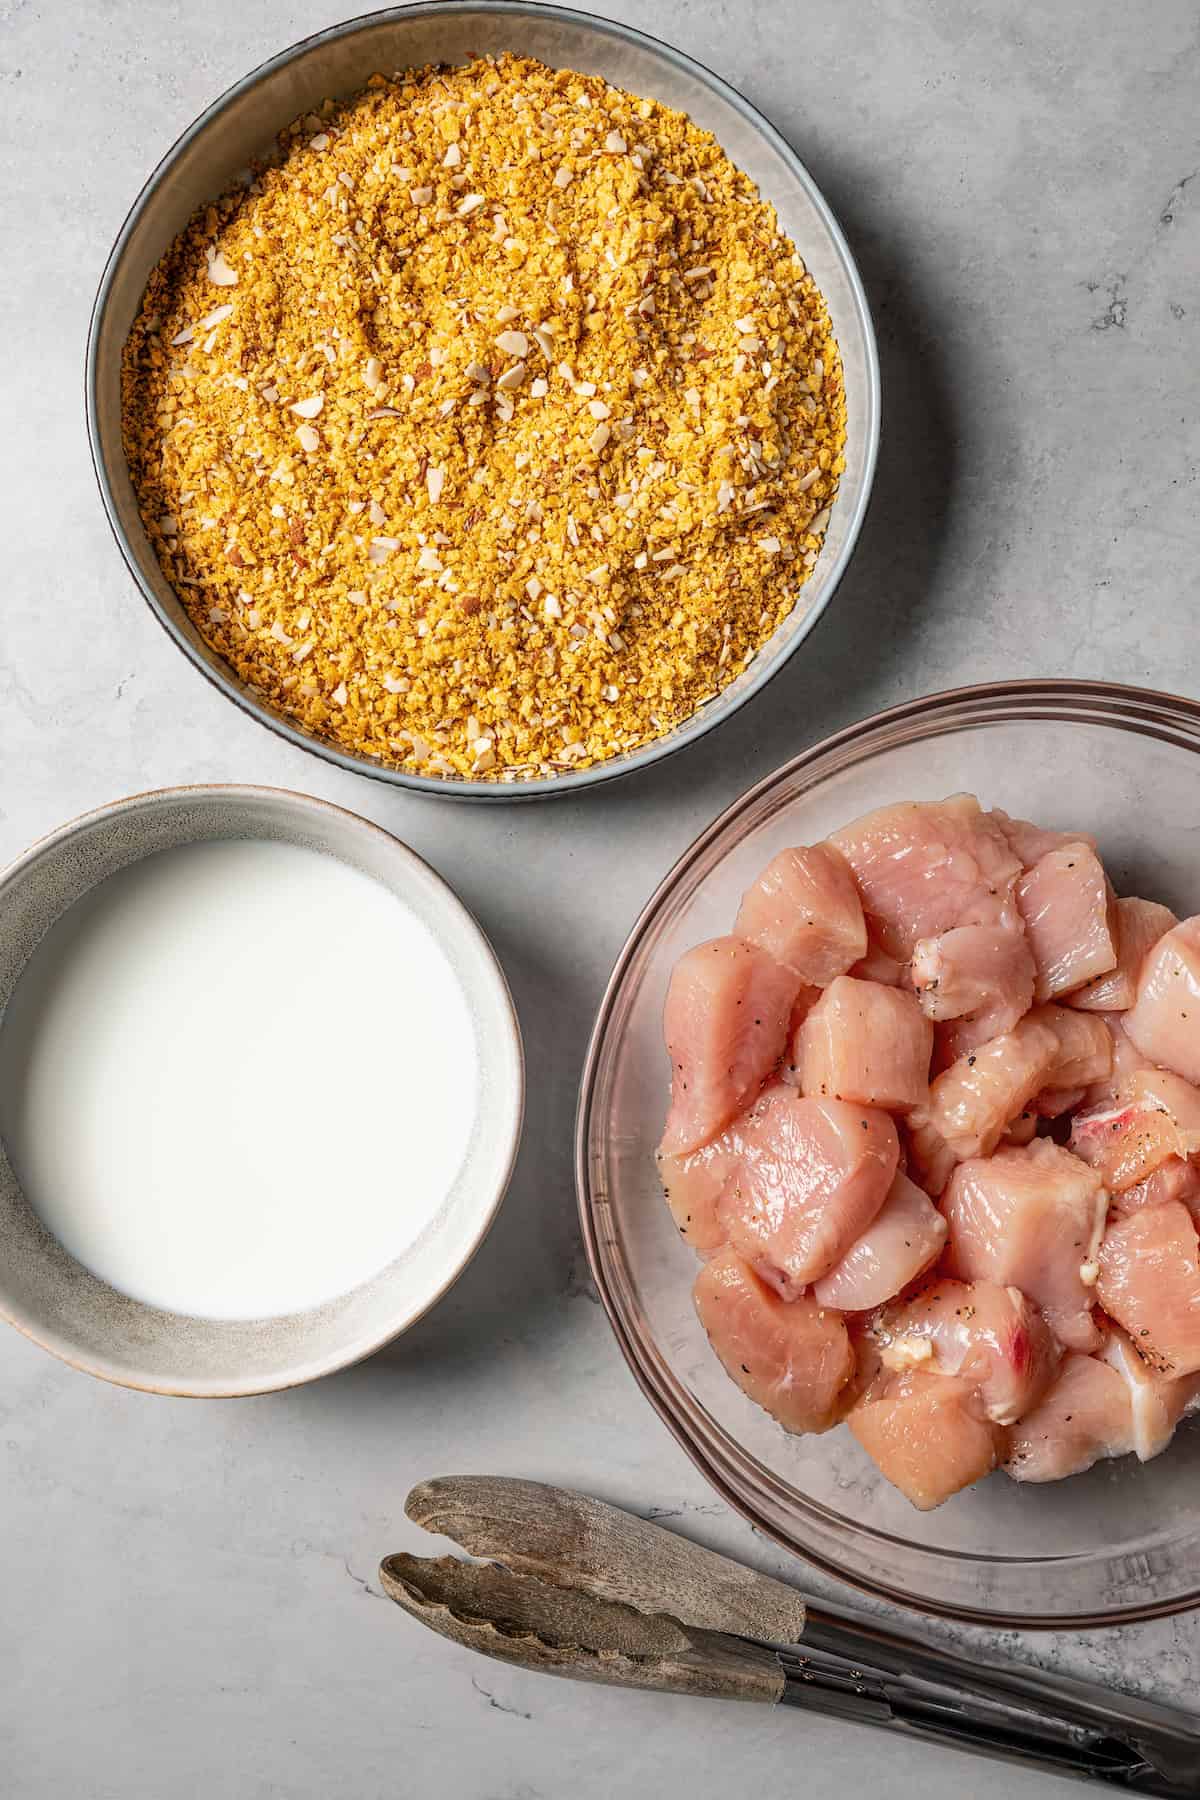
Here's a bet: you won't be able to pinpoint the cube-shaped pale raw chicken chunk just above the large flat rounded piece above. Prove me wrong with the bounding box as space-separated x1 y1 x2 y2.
792 976 934 1112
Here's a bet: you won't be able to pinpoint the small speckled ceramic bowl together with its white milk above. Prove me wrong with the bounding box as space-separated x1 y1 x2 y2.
0 787 524 1395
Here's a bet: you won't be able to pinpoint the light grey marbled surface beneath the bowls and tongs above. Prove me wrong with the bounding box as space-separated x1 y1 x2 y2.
0 0 1200 1800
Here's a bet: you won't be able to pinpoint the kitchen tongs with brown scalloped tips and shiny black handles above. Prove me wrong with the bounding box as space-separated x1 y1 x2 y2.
380 1476 1200 1796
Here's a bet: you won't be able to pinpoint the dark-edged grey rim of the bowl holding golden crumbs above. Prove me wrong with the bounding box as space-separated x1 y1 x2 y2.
85 0 882 803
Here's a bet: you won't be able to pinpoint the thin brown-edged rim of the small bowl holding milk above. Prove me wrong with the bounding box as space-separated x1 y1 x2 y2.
0 781 525 1400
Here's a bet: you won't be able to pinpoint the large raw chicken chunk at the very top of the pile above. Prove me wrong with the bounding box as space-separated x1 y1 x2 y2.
829 794 1020 961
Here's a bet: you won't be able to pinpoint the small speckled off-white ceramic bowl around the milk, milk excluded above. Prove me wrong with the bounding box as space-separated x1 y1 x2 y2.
0 787 524 1397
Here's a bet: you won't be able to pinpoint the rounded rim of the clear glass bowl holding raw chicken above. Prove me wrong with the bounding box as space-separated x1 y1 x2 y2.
574 677 1200 1631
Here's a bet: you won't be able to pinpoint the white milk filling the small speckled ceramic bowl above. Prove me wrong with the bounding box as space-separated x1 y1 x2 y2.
0 841 479 1319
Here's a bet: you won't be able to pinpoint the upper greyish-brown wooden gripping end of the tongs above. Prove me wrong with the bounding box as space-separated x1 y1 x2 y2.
402 1476 804 1643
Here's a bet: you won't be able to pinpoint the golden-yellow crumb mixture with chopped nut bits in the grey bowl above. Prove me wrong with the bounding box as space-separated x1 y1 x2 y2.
124 56 846 779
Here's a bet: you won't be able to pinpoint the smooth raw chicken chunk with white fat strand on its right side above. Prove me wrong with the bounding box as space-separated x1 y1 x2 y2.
943 1138 1108 1350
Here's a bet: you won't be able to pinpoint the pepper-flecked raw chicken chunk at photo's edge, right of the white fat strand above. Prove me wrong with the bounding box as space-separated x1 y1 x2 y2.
1096 1201 1200 1377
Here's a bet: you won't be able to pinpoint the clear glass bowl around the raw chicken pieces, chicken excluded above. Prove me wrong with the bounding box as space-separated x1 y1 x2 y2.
576 682 1200 1627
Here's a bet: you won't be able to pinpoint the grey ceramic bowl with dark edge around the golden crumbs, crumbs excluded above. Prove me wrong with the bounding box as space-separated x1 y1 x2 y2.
86 0 880 801
